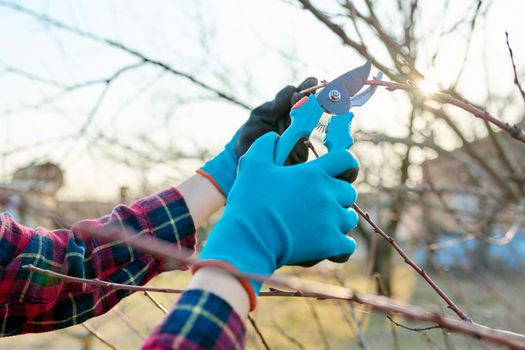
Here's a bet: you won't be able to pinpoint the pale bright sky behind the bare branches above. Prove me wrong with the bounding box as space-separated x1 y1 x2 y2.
0 0 525 200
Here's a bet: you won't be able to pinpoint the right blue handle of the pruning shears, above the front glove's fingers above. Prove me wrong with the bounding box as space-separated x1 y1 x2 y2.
323 112 359 183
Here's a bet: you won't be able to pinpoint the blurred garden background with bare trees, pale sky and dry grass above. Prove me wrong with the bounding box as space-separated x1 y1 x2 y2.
0 0 525 349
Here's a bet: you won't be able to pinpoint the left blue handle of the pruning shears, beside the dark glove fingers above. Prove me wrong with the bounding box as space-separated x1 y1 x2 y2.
274 95 324 165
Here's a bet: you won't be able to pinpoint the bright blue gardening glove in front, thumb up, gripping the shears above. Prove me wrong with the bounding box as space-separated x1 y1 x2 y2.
196 132 359 309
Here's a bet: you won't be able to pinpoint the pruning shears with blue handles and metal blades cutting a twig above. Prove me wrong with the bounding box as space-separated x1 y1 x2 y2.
275 61 382 178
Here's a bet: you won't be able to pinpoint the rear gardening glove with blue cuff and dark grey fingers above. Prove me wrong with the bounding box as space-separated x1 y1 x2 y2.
197 78 317 197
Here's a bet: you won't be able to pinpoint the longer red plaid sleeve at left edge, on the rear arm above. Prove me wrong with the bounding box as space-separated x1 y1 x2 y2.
0 188 196 336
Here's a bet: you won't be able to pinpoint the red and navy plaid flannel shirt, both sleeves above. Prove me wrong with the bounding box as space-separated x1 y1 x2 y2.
0 189 244 349
